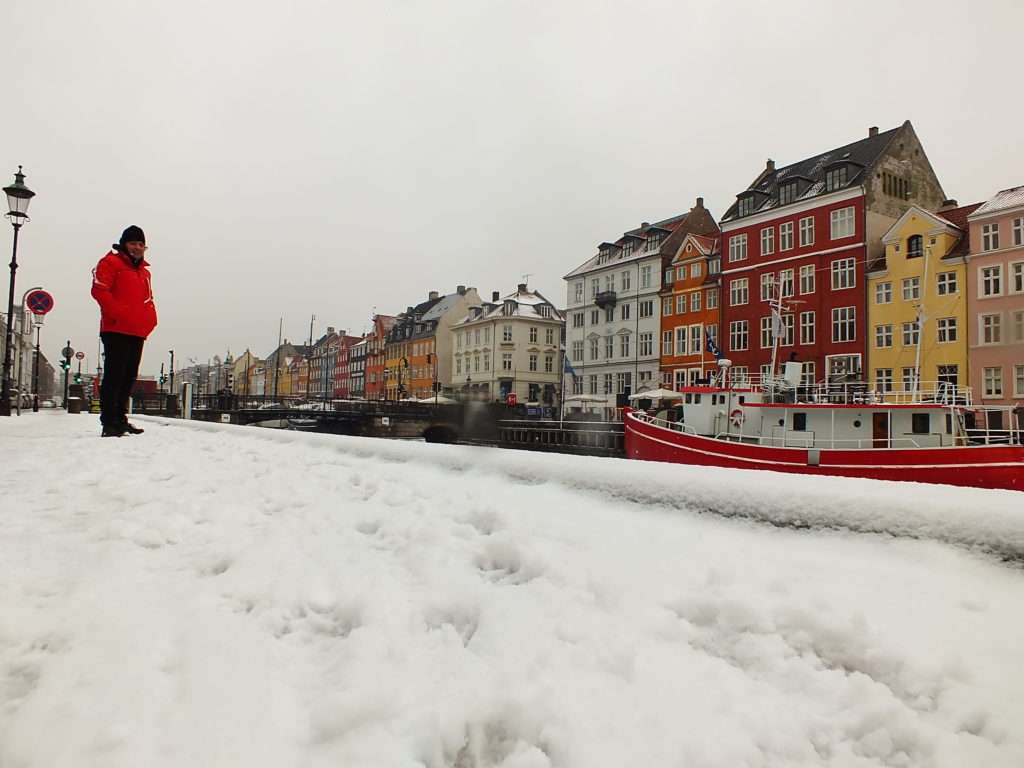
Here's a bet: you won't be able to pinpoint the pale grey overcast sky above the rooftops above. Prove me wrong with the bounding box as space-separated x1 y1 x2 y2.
0 0 1024 374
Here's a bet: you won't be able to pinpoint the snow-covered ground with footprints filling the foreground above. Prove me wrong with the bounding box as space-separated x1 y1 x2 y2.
0 413 1024 768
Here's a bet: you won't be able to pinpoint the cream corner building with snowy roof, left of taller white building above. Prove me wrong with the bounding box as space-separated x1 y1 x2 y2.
452 283 565 408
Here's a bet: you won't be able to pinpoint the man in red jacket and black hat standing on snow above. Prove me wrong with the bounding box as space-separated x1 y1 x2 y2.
92 224 157 437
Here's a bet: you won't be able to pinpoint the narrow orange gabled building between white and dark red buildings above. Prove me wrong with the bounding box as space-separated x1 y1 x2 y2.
660 234 722 389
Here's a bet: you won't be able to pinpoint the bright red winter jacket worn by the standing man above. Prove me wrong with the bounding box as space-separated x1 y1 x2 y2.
92 251 157 339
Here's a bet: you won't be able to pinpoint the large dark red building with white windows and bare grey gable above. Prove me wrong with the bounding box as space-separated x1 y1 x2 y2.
720 122 944 383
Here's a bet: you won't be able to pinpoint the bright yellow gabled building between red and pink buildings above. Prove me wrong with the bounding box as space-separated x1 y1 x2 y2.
867 201 976 392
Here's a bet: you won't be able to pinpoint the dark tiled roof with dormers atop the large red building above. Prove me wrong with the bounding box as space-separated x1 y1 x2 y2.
722 121 909 221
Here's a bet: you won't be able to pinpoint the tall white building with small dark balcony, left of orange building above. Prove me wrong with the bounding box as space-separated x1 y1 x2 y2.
565 198 717 418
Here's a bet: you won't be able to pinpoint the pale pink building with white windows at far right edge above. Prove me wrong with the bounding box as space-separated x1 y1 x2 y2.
967 186 1024 409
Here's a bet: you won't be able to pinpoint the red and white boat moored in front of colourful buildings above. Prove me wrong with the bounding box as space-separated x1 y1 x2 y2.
624 360 1024 490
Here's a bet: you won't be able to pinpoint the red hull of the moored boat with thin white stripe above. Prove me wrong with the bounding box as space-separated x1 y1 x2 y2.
625 414 1024 490
